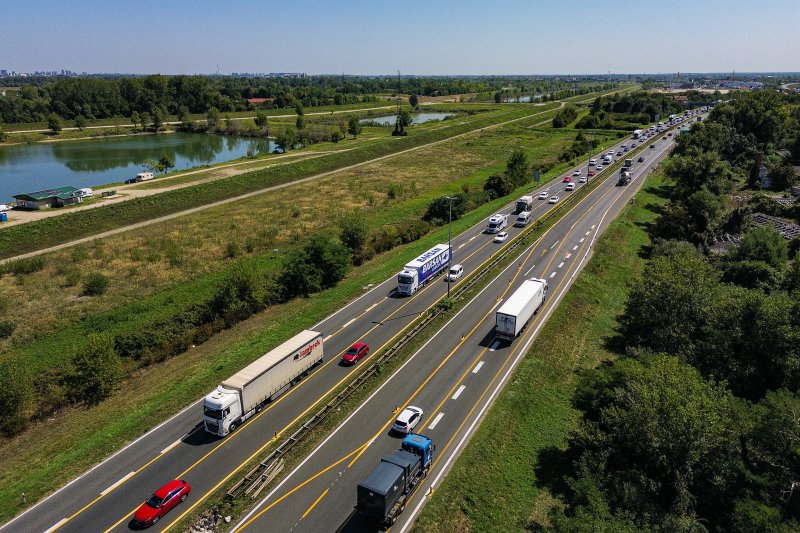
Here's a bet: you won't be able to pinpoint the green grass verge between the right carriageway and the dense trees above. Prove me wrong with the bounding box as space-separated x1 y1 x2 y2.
414 168 665 533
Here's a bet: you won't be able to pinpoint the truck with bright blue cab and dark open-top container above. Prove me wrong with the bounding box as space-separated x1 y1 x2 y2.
356 433 436 527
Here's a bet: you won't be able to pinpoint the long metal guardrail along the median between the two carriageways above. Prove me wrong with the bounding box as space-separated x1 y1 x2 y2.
226 128 664 500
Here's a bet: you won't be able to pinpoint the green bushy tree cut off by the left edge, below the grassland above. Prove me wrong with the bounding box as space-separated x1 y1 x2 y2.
0 359 34 437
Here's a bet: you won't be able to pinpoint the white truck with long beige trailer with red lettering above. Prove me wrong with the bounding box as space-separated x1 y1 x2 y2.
203 330 324 437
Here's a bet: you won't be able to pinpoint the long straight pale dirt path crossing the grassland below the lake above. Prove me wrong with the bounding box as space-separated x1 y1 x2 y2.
0 102 564 265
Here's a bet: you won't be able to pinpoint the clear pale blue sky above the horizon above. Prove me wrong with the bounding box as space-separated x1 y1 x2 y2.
0 0 800 74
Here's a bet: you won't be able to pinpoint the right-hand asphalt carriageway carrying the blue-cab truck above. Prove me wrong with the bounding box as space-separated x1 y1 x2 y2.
227 134 671 532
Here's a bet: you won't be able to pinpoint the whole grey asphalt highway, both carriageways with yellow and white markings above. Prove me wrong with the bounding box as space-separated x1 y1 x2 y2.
0 118 671 533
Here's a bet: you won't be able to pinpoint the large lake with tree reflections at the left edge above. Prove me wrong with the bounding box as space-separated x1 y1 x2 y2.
0 133 276 203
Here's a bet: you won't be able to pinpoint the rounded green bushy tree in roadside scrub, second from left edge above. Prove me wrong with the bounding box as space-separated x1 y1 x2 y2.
69 333 122 405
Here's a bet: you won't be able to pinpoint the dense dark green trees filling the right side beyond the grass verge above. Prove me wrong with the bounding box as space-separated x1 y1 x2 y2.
550 92 800 532
